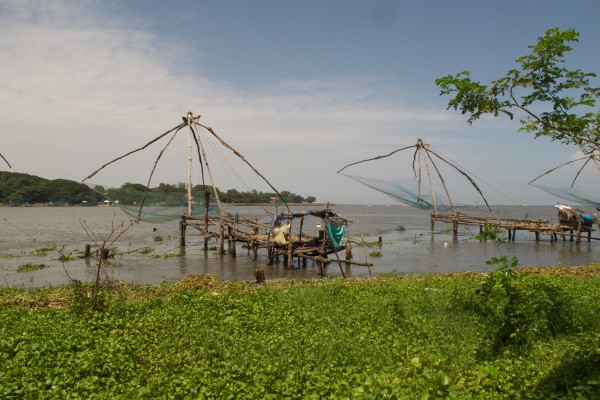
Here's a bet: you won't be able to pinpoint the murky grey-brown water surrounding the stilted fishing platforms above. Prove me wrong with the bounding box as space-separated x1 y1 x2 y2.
0 205 600 287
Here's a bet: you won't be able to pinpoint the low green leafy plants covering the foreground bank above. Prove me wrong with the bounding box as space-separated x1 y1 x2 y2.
0 264 600 399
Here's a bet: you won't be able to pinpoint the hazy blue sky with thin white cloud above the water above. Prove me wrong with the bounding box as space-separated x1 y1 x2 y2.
0 0 600 205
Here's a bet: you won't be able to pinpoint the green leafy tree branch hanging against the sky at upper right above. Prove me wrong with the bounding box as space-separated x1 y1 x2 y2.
435 28 600 154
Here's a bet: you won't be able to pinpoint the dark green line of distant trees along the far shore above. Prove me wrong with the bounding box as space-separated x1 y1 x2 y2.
0 171 316 205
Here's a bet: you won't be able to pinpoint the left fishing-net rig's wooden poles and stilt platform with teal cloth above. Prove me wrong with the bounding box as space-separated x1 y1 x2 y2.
84 112 371 281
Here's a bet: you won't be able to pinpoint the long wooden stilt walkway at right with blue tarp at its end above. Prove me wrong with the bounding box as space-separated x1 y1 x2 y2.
430 208 600 243
